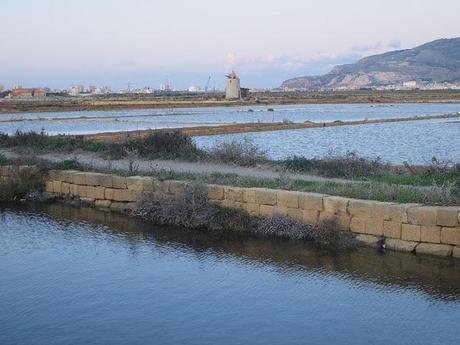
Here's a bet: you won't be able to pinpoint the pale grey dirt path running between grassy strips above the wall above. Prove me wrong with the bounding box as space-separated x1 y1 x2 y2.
0 150 360 183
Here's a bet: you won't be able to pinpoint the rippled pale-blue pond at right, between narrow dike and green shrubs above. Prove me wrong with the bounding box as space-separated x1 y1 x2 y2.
194 119 460 164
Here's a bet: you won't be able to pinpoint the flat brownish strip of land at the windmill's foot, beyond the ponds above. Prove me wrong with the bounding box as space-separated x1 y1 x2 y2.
0 90 460 114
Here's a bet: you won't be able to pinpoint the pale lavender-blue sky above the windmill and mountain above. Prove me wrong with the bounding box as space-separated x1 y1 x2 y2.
0 0 460 89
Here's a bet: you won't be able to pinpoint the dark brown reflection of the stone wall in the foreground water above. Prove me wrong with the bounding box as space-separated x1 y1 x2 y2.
9 204 460 302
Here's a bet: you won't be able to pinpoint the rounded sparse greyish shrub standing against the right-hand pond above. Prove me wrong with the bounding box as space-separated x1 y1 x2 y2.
207 138 268 166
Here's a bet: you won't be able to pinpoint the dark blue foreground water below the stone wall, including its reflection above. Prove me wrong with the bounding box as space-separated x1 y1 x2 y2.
0 205 460 345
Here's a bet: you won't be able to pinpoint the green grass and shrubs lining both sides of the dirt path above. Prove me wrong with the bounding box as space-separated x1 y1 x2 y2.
0 132 460 205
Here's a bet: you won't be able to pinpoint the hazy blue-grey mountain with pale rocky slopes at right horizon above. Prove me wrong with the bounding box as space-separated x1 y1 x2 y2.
282 37 460 89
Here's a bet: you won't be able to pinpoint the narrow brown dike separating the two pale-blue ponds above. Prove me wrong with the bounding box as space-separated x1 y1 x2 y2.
84 113 460 141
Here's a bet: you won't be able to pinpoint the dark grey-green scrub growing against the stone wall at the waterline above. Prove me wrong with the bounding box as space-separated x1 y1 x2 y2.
133 184 345 244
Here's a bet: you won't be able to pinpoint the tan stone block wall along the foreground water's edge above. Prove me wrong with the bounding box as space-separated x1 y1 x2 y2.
38 171 460 257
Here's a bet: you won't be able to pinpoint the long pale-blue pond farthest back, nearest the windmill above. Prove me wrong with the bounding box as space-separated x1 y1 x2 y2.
0 103 460 134
